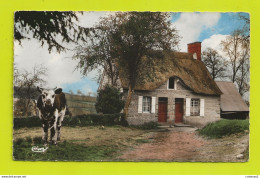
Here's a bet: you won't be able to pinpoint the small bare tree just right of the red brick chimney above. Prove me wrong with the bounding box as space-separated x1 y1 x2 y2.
202 48 227 80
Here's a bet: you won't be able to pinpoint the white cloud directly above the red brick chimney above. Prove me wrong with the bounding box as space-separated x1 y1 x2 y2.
172 12 221 52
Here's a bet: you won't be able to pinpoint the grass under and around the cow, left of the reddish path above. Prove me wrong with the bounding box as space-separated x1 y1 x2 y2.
13 126 148 161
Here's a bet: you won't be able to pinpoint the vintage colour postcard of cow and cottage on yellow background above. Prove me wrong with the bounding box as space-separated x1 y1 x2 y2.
13 11 250 162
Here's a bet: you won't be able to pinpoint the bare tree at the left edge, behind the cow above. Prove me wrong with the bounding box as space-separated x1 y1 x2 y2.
14 65 47 116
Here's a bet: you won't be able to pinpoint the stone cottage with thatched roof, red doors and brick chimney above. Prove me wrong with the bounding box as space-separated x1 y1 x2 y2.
100 42 222 127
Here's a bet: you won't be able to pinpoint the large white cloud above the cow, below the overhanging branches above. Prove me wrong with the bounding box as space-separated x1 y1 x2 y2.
14 39 81 88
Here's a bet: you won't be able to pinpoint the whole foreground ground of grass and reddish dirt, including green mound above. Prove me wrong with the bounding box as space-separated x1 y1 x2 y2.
13 119 249 162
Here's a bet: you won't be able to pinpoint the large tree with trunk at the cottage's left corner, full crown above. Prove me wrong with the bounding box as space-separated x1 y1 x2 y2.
76 12 179 115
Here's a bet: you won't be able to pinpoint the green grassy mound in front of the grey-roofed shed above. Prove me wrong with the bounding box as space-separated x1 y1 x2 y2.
199 119 249 138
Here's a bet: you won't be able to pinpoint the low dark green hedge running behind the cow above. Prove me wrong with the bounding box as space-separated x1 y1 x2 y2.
14 114 128 129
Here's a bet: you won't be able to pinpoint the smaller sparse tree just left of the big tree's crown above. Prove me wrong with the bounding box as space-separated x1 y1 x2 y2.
73 14 119 86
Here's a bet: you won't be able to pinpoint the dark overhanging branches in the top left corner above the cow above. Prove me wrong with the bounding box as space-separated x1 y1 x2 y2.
14 11 88 52
